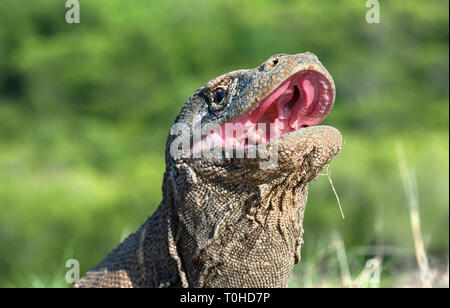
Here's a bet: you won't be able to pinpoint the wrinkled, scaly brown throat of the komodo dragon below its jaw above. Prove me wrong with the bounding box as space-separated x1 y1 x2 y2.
169 174 307 287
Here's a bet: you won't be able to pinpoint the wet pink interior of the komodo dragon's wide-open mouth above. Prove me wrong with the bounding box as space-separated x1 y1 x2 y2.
202 71 334 148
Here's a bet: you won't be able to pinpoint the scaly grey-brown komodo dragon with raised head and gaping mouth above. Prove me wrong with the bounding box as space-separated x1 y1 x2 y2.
75 53 342 288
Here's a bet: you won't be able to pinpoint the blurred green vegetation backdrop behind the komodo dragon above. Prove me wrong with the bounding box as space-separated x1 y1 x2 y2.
0 0 449 287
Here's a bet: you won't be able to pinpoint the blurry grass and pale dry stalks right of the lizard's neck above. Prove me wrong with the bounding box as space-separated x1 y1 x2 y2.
290 141 449 288
